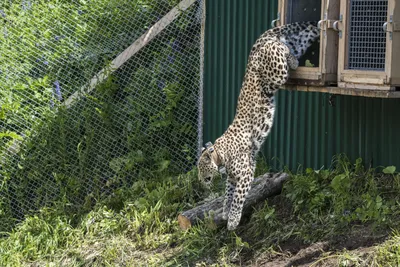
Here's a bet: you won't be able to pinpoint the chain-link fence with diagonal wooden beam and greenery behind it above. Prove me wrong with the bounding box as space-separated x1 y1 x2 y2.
0 0 204 231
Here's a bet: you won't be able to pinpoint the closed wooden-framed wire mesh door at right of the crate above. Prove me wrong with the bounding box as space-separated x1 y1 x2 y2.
338 0 399 90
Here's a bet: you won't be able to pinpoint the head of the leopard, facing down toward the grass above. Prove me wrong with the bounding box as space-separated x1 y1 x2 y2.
197 142 219 188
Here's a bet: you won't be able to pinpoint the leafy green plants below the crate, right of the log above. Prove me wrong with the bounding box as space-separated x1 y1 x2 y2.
285 155 399 232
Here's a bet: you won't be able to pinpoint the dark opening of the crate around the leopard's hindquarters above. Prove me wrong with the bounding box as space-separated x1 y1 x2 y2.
285 0 321 67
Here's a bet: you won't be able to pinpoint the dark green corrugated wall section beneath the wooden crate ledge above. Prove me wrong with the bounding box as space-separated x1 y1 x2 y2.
263 90 400 170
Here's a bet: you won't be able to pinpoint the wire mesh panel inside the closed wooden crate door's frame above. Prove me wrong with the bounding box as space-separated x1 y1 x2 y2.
348 0 388 70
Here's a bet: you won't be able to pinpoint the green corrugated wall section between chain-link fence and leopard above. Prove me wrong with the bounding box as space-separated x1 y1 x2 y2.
203 0 277 141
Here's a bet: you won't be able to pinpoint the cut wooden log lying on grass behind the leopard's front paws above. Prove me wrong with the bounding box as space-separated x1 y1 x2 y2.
178 173 289 230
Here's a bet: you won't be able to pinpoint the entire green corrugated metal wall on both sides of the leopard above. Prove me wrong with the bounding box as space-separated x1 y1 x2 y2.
204 0 400 170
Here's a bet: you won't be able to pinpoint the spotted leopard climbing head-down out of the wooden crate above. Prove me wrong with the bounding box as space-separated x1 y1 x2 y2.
197 22 320 230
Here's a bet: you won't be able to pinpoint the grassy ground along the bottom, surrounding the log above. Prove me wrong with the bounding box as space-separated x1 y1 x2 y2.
0 156 400 266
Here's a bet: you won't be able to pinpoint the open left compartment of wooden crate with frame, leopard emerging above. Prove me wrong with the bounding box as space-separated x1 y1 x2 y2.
278 0 339 86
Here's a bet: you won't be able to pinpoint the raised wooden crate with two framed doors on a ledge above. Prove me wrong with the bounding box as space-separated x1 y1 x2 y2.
276 0 400 97
